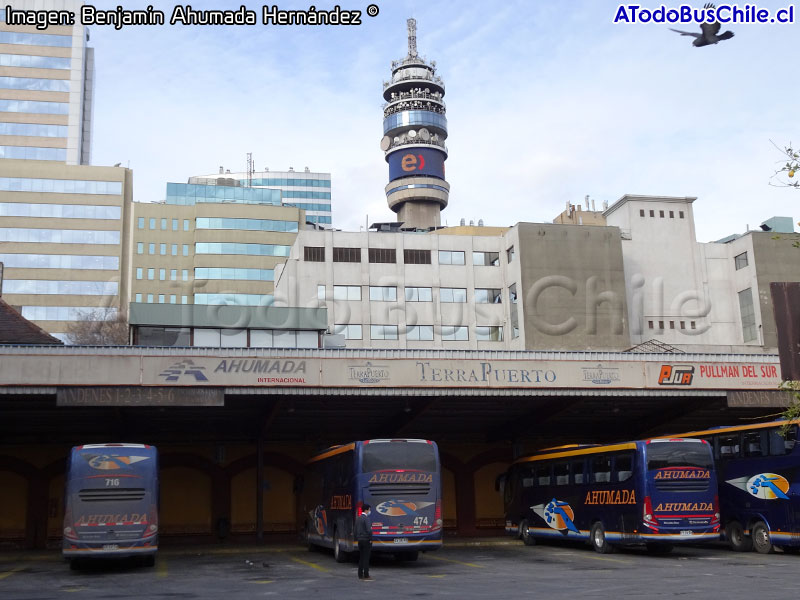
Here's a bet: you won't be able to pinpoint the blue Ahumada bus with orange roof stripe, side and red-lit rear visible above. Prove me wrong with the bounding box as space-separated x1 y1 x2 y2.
498 439 720 553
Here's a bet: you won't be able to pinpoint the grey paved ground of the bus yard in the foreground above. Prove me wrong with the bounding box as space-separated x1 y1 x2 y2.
0 539 800 600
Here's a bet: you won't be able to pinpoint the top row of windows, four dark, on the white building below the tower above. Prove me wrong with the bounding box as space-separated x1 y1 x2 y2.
303 246 506 267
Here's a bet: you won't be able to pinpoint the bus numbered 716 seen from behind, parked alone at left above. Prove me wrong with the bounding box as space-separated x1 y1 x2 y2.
62 444 158 568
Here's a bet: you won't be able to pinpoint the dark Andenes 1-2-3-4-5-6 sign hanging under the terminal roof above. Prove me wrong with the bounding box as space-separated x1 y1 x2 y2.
56 386 225 406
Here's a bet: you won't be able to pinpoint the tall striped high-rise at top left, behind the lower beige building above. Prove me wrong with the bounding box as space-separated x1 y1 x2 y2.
0 0 94 165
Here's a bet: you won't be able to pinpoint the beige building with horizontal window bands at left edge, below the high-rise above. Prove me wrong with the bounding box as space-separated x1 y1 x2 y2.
0 159 133 340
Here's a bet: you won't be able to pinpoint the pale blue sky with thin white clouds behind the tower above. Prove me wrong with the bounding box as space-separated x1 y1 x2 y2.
90 0 800 242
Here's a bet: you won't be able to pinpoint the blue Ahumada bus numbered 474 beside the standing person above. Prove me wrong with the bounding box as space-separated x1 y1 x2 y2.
299 439 442 562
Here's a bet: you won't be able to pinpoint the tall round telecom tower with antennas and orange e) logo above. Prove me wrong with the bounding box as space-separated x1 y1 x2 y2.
381 19 450 229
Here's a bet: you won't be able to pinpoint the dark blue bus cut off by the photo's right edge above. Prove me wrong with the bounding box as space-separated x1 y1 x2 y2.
685 421 800 554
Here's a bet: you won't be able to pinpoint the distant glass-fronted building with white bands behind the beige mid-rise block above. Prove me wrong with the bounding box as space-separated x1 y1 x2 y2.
189 167 333 227
